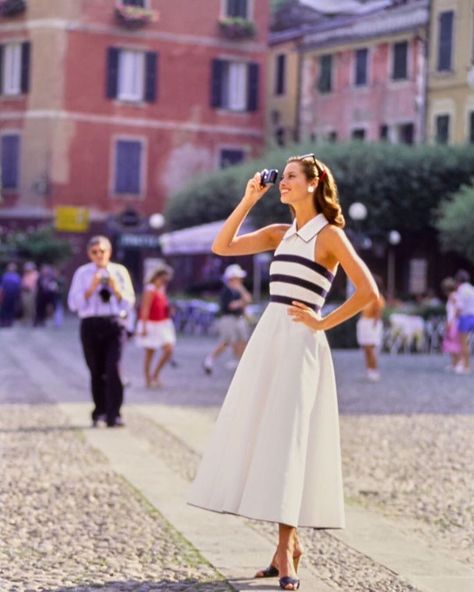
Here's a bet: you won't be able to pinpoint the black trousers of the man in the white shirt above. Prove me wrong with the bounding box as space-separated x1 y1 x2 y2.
81 317 125 425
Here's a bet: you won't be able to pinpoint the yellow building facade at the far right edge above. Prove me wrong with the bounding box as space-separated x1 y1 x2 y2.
427 0 474 144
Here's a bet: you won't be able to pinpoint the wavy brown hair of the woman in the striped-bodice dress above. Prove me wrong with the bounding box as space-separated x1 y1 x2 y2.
286 156 346 228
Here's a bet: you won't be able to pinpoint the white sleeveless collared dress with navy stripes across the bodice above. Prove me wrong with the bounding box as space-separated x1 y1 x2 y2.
188 214 344 528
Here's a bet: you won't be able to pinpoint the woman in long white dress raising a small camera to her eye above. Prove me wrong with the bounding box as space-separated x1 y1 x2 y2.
188 154 378 590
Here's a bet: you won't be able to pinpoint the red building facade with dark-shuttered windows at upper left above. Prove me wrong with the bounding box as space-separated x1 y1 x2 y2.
0 0 269 220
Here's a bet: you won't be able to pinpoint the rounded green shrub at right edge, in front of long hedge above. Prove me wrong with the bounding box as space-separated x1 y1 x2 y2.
436 185 474 263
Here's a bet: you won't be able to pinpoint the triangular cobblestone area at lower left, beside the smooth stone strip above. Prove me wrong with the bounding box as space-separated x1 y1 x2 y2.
0 344 231 592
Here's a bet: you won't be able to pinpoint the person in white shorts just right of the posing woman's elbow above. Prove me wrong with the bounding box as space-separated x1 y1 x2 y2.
356 277 385 382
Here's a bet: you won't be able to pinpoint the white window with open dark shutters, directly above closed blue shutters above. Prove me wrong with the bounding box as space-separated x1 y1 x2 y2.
106 47 158 103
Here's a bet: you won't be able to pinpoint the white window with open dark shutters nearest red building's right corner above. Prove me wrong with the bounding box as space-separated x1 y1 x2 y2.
211 60 259 112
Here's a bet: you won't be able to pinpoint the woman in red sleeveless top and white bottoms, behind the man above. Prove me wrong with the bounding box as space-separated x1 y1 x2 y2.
135 264 176 388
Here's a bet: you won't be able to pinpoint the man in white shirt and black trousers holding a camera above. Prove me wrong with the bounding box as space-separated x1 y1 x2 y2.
68 236 135 427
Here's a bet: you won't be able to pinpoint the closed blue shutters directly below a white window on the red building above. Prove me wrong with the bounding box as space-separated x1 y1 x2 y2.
114 139 144 196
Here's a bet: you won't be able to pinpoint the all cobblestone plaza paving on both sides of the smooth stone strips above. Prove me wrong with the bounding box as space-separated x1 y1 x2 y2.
0 324 474 592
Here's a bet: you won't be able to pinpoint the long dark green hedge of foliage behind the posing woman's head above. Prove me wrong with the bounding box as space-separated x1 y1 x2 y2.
166 142 474 235
